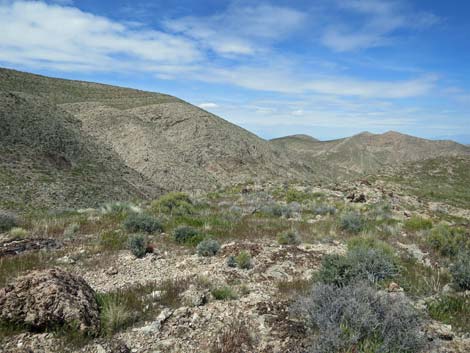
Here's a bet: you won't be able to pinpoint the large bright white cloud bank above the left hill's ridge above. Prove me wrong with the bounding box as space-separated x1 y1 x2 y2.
0 2 202 71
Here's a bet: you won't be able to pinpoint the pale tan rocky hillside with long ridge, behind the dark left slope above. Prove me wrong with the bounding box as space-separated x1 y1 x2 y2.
0 70 301 195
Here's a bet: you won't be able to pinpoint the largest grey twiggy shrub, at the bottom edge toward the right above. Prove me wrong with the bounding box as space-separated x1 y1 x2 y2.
293 283 424 353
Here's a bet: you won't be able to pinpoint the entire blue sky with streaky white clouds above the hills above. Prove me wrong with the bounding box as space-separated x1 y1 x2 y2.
0 0 470 143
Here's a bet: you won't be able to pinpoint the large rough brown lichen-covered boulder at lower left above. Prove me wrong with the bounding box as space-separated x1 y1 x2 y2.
0 269 100 334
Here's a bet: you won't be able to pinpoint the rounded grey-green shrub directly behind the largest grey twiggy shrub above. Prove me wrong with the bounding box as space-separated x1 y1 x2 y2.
318 238 399 286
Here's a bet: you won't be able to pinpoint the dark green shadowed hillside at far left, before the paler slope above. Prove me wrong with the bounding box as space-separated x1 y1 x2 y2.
0 91 161 209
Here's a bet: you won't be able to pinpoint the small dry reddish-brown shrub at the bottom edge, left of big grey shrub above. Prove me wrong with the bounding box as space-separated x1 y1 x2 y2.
210 321 255 353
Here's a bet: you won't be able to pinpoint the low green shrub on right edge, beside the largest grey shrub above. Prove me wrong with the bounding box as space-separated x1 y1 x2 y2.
427 294 470 332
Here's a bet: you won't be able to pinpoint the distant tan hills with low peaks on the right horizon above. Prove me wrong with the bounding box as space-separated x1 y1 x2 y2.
271 131 470 179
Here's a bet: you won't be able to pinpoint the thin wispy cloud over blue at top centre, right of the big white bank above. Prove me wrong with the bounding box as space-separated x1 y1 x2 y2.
165 4 306 55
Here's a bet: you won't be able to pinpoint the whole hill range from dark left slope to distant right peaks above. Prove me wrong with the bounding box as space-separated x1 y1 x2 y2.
0 69 470 208
